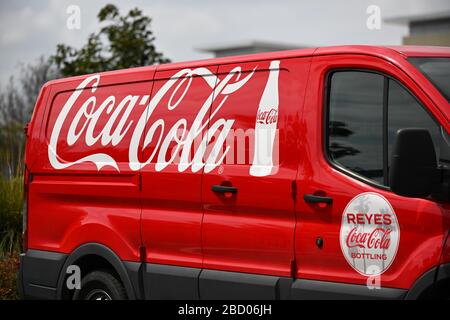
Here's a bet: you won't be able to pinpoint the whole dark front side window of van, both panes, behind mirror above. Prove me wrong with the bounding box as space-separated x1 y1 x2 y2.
326 71 442 186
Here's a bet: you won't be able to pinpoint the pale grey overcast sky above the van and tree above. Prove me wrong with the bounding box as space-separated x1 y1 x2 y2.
0 0 450 86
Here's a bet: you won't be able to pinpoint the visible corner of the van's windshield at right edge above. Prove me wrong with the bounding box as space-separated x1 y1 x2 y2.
408 57 450 102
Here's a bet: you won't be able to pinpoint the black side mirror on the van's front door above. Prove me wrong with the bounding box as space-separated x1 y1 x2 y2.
389 129 439 197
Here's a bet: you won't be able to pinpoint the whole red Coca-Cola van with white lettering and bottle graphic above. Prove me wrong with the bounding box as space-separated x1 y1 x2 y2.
19 46 450 300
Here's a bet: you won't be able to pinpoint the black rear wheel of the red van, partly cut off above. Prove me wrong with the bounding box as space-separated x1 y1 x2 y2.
73 271 127 300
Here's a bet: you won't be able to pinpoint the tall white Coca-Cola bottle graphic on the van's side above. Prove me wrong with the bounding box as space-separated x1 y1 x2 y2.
250 60 280 177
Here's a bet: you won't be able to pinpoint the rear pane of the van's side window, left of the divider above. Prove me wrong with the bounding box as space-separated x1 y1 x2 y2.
328 71 384 183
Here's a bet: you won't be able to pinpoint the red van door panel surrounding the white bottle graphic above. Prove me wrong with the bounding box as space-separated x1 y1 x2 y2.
202 57 311 276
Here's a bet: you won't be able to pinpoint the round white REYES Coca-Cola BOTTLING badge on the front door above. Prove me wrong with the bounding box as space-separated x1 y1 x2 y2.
339 192 400 276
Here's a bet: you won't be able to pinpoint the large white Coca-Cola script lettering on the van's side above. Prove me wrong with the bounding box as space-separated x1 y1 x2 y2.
48 67 274 172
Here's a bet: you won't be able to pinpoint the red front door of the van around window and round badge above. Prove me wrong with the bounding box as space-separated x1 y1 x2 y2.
296 53 450 289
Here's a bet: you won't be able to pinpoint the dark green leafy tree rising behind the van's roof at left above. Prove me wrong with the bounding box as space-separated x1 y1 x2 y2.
51 4 169 76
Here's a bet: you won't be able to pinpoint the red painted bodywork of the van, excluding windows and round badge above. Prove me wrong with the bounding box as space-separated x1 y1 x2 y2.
21 46 450 298
